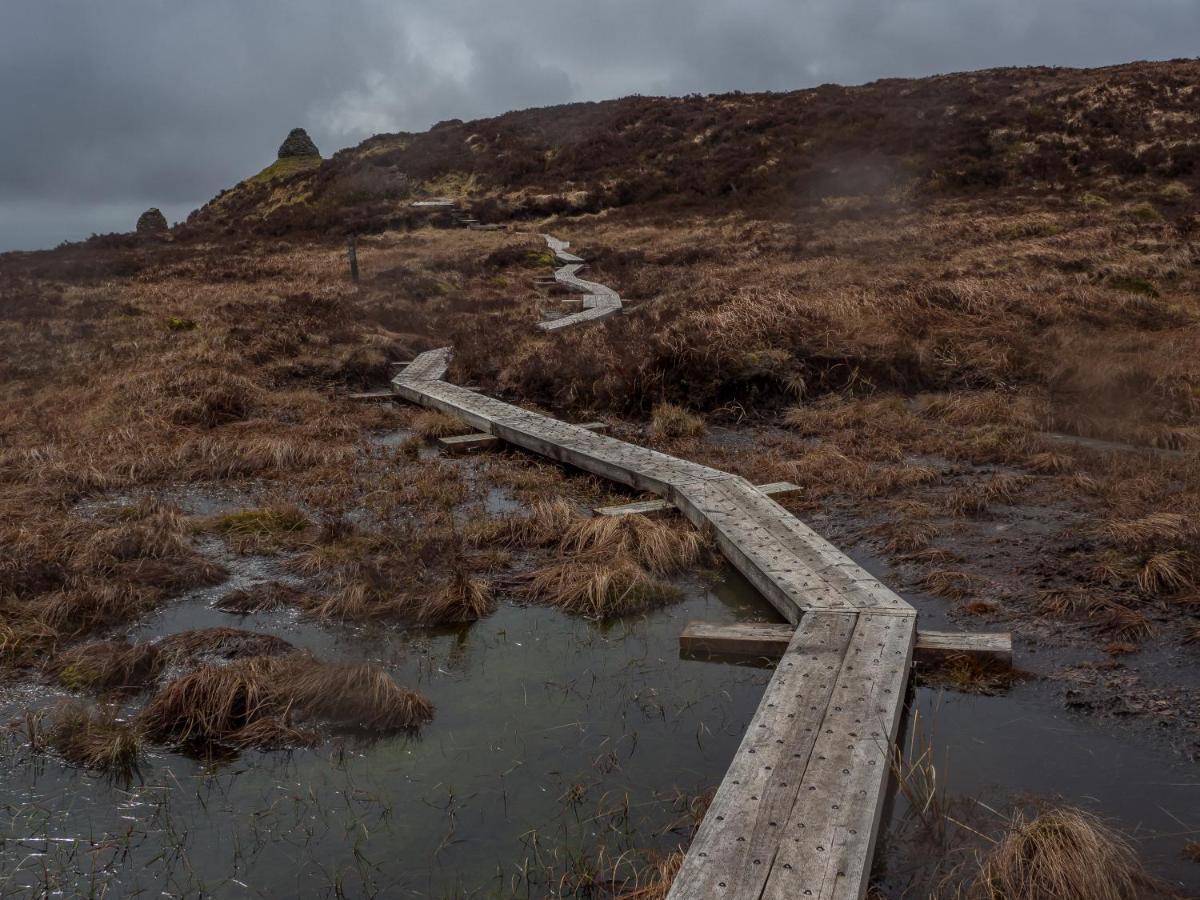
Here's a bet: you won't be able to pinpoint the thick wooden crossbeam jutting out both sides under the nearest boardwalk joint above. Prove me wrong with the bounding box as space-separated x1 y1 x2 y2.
679 620 1013 666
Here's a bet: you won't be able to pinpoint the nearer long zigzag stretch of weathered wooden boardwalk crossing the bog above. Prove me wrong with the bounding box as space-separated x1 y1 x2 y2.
392 343 917 900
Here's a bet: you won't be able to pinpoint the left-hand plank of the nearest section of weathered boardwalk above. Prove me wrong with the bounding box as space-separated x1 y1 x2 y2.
667 612 856 900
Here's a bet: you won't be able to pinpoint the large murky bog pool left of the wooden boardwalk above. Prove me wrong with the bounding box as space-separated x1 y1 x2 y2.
0 564 768 896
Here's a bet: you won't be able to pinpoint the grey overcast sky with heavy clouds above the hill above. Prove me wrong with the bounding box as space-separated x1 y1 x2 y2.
0 0 1200 251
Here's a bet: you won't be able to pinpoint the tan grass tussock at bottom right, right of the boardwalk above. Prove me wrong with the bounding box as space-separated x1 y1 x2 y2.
968 806 1170 900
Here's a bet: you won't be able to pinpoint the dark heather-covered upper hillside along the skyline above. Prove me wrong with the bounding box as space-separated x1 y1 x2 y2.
182 60 1200 234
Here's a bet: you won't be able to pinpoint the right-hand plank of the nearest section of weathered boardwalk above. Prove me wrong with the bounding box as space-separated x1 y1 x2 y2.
762 612 917 900
